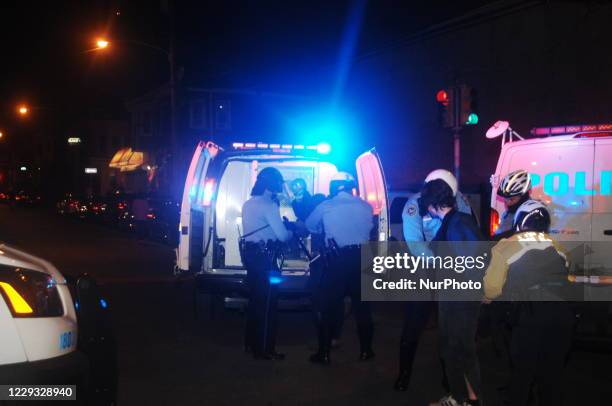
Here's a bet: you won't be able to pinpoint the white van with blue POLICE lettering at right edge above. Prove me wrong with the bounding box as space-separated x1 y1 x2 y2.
487 121 612 284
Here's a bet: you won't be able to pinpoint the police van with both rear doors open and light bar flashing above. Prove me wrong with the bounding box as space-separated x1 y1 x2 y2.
175 142 389 298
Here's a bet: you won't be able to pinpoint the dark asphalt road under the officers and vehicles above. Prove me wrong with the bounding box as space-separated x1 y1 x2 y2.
0 206 612 405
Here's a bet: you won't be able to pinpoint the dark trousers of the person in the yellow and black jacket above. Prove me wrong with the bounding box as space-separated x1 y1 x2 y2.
509 302 575 406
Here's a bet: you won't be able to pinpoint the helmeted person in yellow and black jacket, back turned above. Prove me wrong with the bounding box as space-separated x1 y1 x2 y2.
483 200 575 406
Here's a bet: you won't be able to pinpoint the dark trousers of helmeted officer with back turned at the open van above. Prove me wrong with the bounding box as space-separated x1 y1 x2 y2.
319 247 374 352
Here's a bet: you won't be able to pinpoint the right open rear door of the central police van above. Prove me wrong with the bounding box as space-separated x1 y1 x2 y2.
355 149 389 241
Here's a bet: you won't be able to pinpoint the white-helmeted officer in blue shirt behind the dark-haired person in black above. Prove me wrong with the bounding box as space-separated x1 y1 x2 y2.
394 169 472 391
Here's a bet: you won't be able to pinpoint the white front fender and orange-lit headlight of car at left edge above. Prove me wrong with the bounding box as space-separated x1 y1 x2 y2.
0 245 87 384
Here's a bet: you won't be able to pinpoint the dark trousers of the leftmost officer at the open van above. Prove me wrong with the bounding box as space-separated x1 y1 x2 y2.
243 244 278 355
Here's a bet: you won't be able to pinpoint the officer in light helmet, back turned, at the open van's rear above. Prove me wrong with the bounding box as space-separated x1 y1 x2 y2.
306 172 374 365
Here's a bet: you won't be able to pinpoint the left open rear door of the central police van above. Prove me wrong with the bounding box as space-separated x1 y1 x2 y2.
174 141 219 274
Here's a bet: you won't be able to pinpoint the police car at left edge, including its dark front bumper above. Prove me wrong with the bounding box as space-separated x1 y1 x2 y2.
0 244 117 405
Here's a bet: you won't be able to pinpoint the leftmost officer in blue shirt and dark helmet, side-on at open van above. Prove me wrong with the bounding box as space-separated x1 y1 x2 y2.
241 167 292 360
